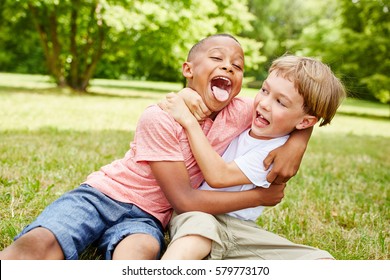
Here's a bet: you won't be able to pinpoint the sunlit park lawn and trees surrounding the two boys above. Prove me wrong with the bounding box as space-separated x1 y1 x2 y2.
0 0 390 260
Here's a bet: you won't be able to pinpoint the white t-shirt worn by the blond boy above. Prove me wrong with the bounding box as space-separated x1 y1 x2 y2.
200 129 289 221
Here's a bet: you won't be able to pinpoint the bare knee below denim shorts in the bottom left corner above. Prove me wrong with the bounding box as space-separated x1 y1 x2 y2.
0 227 64 260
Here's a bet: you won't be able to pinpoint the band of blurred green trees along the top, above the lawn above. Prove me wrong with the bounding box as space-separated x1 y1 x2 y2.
0 0 390 106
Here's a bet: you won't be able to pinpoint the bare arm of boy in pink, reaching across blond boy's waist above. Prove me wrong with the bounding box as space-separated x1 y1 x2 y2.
149 161 285 215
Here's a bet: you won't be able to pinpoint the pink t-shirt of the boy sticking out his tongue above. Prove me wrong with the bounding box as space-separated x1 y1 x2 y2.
84 98 253 227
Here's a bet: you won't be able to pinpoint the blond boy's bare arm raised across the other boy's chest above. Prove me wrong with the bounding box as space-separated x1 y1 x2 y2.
165 94 251 188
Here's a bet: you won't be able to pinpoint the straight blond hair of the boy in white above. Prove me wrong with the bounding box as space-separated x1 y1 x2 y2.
269 55 346 126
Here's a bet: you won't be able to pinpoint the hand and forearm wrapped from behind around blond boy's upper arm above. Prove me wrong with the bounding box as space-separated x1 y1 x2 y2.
263 127 313 184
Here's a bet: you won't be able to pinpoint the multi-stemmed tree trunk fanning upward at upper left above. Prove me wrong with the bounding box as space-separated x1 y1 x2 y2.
28 0 106 92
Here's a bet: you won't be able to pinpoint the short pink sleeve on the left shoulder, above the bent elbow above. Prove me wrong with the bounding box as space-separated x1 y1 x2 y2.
133 105 184 161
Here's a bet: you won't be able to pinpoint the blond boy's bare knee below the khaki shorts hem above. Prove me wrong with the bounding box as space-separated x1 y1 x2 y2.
161 235 212 260
